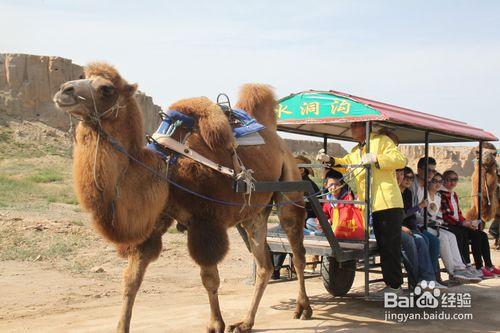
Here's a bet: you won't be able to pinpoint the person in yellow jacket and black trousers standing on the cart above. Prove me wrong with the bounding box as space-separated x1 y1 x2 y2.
317 122 407 297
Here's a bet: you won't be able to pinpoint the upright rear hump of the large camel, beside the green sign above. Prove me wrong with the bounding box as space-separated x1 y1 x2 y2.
236 83 276 130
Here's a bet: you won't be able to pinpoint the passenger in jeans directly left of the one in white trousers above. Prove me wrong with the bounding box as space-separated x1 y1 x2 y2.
410 157 441 281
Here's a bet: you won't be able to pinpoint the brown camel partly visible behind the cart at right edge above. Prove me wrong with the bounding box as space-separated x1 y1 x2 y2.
465 142 499 222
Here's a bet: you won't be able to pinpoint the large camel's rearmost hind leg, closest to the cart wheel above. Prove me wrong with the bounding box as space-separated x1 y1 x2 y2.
275 194 312 319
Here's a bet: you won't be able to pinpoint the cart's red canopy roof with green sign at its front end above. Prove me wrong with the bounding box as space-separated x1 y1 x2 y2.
276 90 498 143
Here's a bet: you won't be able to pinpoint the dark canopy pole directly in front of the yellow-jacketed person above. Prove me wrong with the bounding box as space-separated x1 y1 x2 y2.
363 121 372 298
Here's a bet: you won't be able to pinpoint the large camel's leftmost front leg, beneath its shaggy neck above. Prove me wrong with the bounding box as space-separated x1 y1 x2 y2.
117 220 172 333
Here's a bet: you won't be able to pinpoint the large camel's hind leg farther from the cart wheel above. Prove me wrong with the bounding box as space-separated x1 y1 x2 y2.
229 208 273 333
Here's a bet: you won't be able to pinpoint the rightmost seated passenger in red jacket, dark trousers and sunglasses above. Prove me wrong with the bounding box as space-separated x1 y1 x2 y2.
440 170 500 279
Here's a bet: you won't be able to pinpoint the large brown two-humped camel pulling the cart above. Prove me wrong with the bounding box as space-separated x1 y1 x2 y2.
54 63 312 332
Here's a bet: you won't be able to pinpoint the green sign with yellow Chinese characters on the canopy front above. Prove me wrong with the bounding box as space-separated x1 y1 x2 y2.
276 91 381 123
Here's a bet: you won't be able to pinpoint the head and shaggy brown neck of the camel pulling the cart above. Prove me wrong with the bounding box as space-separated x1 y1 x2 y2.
55 64 168 244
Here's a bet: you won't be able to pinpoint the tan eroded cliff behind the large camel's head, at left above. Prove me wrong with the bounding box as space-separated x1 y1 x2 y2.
0 53 161 133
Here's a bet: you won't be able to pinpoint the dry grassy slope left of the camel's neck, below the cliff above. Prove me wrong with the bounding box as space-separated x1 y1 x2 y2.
0 121 77 209
